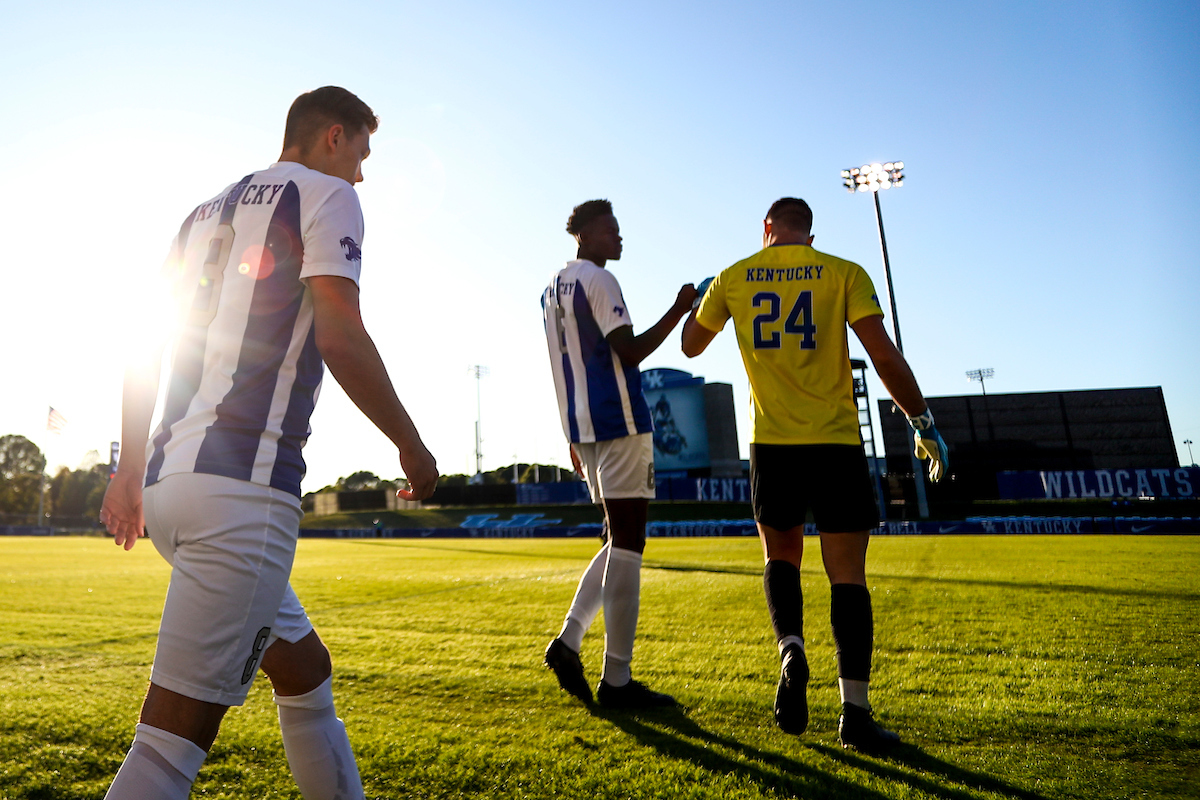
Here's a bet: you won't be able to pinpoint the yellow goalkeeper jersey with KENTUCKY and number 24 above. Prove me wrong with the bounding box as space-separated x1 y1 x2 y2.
696 245 883 445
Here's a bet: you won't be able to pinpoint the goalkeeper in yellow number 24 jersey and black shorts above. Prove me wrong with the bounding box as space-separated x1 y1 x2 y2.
683 198 948 752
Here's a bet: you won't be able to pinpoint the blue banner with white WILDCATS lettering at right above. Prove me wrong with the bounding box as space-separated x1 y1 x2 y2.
996 467 1200 500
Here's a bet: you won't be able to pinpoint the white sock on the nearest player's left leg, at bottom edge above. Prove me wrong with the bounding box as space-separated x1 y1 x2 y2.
104 722 208 800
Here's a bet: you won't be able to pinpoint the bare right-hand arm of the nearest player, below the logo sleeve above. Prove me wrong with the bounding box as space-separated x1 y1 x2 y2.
307 275 438 500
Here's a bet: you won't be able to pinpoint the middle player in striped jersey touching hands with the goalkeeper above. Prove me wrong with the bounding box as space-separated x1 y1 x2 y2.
541 200 696 708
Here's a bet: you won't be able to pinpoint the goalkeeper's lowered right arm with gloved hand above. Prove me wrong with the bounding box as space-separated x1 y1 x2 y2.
851 314 950 482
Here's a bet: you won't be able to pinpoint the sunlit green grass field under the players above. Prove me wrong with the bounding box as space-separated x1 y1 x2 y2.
0 536 1200 800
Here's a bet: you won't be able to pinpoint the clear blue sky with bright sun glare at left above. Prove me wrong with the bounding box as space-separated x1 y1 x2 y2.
0 2 1200 491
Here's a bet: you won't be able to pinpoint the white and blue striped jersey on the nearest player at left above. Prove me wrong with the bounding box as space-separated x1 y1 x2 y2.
146 162 362 497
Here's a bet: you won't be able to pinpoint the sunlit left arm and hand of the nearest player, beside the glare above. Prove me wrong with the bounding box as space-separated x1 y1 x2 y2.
100 343 163 549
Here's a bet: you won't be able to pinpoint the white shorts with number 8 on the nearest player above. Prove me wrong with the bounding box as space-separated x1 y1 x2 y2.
144 473 312 705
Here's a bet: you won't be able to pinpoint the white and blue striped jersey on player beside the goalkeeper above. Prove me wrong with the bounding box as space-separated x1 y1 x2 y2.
541 259 654 443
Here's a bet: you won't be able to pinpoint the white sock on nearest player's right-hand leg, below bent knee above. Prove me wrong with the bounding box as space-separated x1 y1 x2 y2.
275 675 362 800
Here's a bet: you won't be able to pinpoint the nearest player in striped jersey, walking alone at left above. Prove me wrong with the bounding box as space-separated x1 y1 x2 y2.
101 86 437 800
